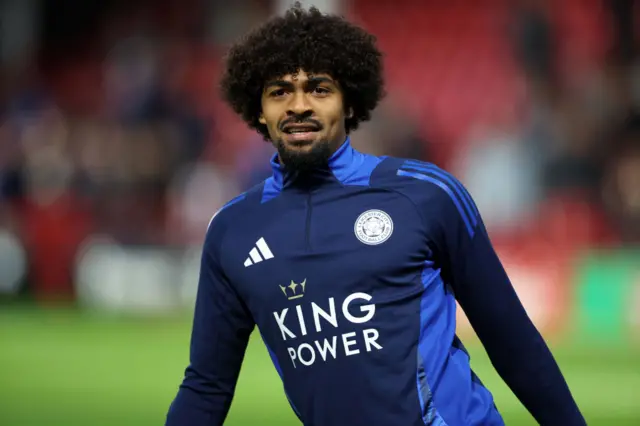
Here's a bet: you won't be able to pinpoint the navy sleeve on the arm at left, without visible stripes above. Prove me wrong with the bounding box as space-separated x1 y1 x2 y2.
166 218 254 426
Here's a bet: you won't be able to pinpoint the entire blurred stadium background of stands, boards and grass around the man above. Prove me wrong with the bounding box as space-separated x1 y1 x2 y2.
0 0 640 426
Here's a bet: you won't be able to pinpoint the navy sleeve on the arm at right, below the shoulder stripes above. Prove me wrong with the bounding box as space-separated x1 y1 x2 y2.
432 181 586 426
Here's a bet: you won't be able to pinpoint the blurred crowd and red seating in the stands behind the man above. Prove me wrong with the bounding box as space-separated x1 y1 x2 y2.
0 0 640 302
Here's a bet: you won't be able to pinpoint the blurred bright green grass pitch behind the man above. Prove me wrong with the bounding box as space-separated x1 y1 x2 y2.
0 306 640 426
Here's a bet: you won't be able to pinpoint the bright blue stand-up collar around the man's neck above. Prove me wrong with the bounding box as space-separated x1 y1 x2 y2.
271 137 363 190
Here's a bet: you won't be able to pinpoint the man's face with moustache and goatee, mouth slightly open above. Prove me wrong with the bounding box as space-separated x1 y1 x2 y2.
260 71 349 171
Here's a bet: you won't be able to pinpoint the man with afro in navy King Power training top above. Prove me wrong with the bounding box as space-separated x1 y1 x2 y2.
167 5 585 426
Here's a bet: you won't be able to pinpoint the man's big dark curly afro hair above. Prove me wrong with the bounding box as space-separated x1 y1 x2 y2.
221 2 384 140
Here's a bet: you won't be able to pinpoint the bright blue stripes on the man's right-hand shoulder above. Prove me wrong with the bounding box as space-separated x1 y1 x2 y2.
397 160 480 237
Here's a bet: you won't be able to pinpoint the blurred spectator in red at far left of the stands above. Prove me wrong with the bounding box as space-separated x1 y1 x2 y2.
10 102 91 298
